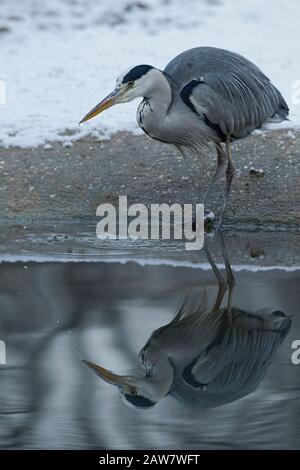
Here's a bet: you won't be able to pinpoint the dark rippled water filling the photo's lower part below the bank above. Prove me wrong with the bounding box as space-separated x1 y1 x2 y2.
0 255 300 449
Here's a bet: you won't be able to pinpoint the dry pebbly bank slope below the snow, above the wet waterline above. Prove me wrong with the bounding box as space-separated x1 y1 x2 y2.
0 130 300 230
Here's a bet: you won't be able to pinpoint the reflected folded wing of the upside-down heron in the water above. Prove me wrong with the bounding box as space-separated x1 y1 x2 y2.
191 315 291 393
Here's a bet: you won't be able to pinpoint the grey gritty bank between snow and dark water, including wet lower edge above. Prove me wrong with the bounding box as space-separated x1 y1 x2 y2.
0 130 300 266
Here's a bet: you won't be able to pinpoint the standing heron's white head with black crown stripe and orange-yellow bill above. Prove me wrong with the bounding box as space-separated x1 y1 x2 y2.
79 65 165 124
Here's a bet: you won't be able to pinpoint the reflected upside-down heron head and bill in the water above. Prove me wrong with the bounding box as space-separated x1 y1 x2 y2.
83 360 161 408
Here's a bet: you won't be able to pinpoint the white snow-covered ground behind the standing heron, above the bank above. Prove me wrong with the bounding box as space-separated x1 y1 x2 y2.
0 0 300 147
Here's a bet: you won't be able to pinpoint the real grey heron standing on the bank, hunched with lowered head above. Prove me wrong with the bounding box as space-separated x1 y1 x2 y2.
79 47 289 228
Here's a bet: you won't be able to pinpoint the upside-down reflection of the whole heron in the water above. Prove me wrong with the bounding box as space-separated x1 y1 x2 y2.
84 235 291 408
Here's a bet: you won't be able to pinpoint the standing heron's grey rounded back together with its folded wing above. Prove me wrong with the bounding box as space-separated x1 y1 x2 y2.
165 47 288 138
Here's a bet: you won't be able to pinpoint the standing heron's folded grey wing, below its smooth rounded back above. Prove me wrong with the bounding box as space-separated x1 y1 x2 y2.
180 70 288 140
